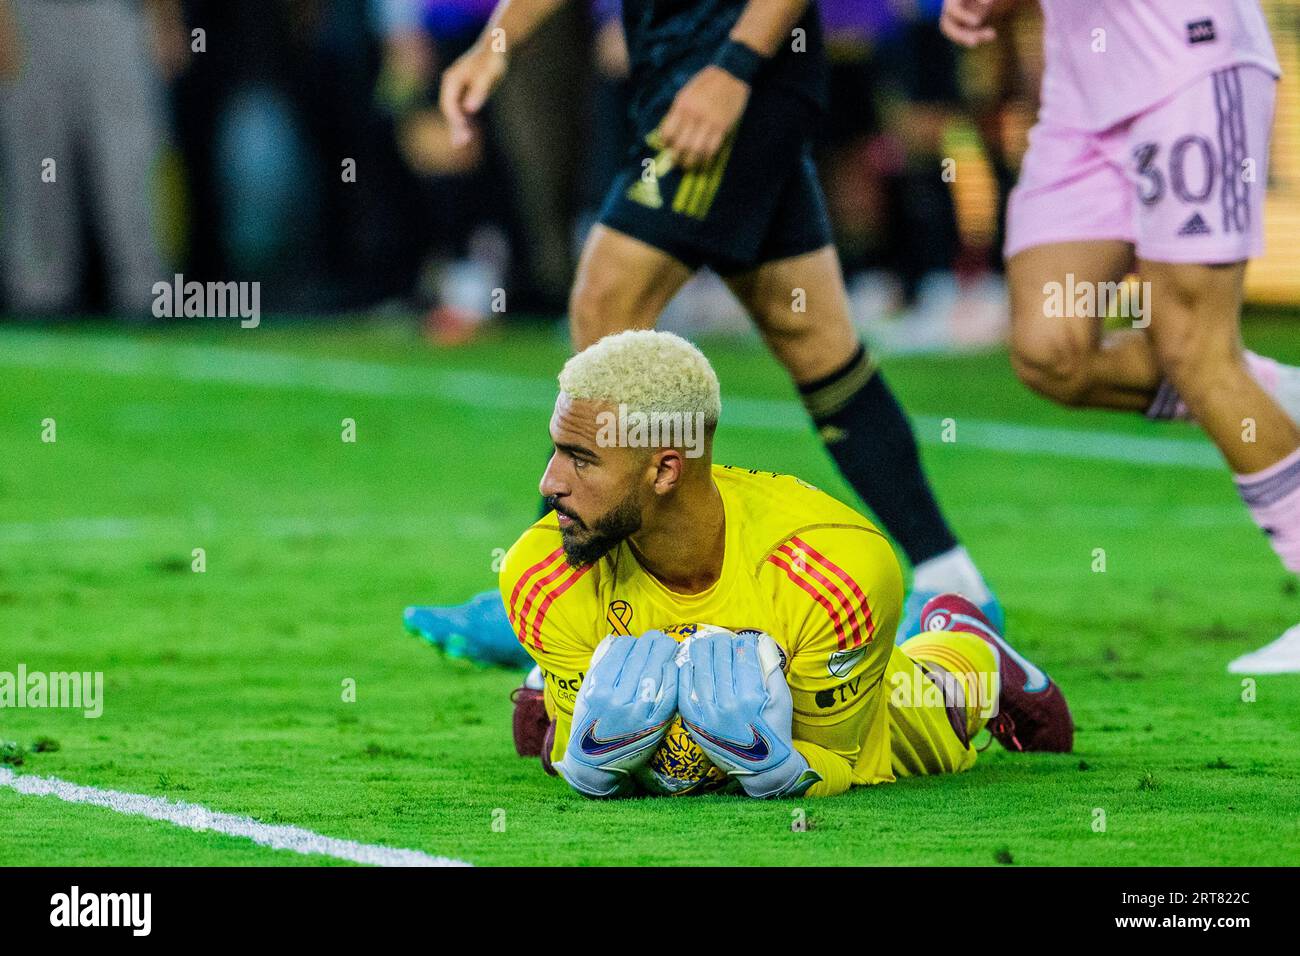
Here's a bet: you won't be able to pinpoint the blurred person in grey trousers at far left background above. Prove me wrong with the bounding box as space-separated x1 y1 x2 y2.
0 0 176 319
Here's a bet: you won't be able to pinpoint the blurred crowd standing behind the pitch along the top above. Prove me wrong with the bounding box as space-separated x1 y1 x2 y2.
0 0 1300 345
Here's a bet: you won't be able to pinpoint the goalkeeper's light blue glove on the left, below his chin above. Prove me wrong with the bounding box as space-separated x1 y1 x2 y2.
555 631 677 797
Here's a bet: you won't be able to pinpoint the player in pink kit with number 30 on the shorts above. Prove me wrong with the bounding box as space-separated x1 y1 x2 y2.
941 0 1300 672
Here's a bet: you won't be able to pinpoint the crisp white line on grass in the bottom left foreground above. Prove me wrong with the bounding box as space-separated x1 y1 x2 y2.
0 767 469 866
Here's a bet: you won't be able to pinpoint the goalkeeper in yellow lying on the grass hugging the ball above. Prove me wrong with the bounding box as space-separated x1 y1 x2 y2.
501 332 1074 797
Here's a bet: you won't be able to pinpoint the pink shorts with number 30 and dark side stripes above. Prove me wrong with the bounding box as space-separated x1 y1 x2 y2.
1004 66 1277 263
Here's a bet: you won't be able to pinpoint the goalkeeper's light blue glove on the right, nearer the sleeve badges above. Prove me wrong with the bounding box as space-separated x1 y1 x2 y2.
677 633 822 797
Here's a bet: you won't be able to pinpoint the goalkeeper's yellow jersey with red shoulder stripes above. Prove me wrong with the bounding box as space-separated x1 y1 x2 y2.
501 464 911 795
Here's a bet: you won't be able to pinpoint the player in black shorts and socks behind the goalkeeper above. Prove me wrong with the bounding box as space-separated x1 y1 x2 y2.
407 0 1002 660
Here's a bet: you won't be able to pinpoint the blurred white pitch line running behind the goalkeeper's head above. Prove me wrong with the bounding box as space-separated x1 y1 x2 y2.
0 330 1225 471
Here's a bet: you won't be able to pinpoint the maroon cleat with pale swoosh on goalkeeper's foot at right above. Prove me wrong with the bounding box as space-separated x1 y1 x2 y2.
920 594 1074 753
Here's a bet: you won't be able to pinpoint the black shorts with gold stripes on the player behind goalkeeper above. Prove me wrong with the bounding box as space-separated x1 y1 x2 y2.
601 90 831 276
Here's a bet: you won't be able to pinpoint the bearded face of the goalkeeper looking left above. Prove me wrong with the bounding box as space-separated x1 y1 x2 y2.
540 393 654 567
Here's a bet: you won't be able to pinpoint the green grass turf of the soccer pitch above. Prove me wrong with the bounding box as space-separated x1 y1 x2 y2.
0 324 1300 865
